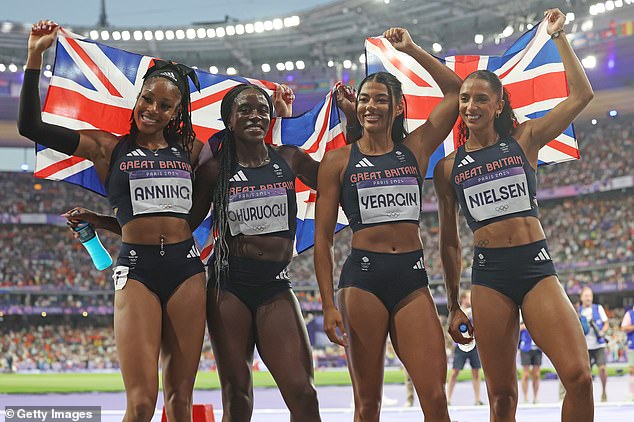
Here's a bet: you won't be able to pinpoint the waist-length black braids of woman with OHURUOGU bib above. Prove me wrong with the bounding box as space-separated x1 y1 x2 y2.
212 84 273 285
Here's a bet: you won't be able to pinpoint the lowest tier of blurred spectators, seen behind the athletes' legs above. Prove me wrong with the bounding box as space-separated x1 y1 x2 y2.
0 307 627 372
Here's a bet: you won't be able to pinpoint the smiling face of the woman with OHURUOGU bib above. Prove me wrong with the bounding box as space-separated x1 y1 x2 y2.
229 89 271 142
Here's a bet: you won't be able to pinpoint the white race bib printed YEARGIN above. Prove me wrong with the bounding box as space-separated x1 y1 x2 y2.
357 177 420 224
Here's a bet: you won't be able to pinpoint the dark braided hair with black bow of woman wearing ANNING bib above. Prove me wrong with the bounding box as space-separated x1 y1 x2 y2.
129 60 200 153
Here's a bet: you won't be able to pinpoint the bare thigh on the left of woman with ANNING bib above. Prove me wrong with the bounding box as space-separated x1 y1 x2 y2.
114 279 162 392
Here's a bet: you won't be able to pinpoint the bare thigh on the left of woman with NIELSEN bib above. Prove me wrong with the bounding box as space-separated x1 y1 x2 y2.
471 284 519 389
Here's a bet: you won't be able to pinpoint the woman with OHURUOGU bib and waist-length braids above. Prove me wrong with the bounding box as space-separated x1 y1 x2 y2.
192 85 320 422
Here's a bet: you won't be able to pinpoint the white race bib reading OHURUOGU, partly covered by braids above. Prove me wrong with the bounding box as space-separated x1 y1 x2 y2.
229 188 288 236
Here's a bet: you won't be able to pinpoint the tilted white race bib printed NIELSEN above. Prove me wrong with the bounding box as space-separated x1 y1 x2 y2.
463 167 531 221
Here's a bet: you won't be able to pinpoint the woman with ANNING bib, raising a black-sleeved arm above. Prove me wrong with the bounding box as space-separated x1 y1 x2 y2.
18 20 205 421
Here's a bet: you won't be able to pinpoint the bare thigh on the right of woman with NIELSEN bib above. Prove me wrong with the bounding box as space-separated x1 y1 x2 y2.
522 276 590 380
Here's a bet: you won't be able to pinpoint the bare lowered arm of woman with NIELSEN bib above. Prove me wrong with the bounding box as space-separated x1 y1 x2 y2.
434 155 473 344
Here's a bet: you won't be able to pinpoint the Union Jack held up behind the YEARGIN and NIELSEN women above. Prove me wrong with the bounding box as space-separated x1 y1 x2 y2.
365 21 579 178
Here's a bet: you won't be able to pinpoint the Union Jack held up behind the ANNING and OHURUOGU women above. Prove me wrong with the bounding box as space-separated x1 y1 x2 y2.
35 28 346 258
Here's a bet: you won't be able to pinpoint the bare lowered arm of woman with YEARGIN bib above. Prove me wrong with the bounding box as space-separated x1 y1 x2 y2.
315 148 347 346
